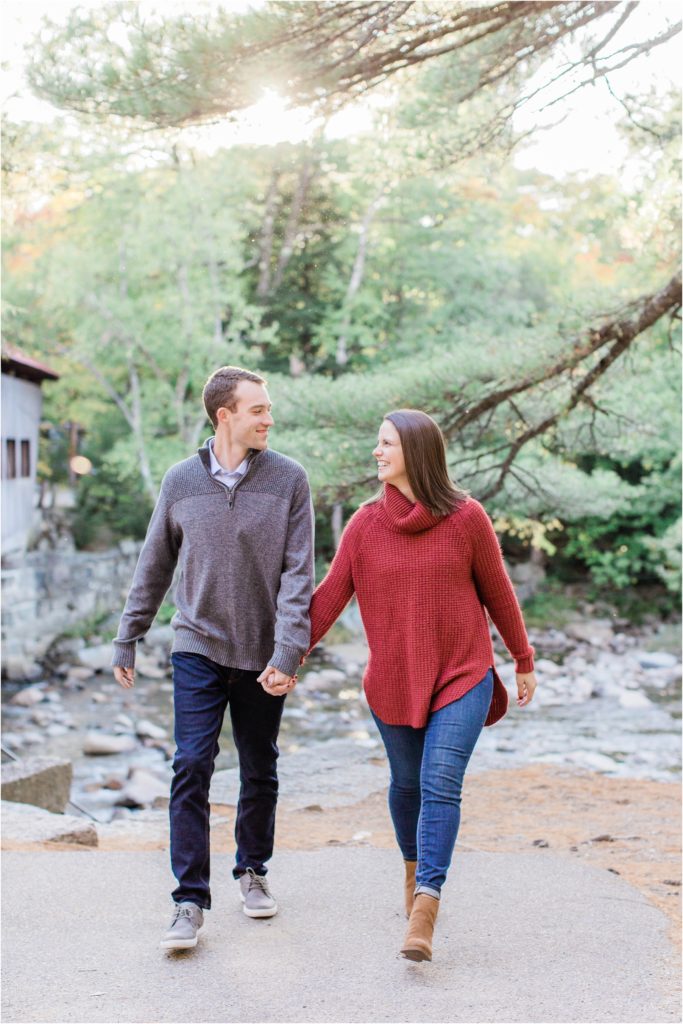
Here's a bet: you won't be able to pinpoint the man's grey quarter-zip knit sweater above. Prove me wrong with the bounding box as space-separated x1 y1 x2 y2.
112 440 313 676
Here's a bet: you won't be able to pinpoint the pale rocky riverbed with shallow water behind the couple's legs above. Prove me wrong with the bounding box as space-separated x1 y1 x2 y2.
2 617 681 802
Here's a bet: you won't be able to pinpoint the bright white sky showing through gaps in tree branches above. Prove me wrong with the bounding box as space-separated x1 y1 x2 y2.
0 0 683 177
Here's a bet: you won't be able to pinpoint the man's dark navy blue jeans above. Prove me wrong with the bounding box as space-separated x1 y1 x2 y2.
169 653 285 909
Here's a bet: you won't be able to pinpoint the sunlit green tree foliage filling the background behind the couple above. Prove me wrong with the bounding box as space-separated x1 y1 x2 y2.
3 12 681 615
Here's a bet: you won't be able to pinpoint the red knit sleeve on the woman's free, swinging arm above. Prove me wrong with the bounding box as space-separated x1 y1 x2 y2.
469 499 533 672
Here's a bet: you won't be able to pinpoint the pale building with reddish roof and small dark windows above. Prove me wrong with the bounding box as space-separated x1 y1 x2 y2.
1 344 59 555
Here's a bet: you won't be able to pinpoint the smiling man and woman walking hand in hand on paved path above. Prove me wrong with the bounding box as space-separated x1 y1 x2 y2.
113 367 536 961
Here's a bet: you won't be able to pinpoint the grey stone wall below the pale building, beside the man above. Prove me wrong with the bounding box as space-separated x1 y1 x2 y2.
2 541 141 679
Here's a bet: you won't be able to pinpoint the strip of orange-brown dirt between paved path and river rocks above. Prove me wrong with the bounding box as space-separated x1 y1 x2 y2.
80 765 681 945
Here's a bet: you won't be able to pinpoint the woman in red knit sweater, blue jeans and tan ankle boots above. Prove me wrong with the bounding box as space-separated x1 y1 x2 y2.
310 410 536 961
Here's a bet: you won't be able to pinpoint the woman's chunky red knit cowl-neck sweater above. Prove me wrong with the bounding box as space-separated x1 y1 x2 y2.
310 484 533 728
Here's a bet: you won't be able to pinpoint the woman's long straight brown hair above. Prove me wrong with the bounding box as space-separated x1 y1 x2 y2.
384 409 469 515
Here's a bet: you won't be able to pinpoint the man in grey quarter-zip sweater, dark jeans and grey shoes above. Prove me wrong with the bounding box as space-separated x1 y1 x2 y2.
113 367 313 949
